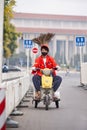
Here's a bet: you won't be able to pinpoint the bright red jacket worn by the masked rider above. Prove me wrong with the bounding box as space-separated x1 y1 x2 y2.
32 55 58 76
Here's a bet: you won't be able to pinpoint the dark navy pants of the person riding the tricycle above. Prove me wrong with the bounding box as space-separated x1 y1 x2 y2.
32 75 62 92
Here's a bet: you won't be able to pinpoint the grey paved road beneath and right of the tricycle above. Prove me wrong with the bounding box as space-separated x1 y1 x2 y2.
6 73 87 130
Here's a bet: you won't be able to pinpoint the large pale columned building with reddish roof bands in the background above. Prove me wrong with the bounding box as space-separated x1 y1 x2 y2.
11 13 87 67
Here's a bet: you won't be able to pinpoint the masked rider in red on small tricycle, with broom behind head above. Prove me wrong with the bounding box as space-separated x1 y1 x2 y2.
32 33 62 110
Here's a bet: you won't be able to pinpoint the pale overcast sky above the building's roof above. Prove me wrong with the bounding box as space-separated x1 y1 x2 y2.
14 0 87 16
